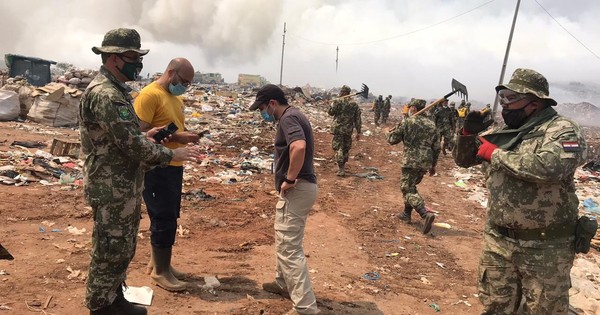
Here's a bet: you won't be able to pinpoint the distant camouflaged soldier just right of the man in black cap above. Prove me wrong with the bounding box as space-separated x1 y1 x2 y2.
327 85 362 176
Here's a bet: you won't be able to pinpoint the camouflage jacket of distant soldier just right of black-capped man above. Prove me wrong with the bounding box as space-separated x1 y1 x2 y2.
327 99 362 134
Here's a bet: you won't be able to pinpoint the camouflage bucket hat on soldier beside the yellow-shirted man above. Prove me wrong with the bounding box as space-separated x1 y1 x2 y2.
92 28 149 56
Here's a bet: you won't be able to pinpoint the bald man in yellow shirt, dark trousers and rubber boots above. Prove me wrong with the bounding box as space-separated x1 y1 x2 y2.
134 58 200 291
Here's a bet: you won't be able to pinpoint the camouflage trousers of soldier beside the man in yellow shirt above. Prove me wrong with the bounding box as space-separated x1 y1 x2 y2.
85 197 141 310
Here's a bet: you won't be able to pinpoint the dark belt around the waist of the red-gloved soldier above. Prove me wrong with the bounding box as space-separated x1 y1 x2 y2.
490 224 575 241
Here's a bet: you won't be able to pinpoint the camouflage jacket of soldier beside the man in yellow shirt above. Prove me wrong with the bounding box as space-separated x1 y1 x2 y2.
79 67 173 206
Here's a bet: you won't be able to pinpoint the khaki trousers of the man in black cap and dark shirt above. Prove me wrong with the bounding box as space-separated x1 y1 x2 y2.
275 180 319 314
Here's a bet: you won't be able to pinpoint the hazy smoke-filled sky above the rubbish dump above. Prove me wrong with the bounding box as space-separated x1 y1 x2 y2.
0 0 600 105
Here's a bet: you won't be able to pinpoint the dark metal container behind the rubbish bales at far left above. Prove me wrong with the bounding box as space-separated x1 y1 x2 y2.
4 54 56 86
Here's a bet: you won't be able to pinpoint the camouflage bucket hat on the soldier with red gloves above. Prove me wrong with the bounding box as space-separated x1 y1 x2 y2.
496 68 556 106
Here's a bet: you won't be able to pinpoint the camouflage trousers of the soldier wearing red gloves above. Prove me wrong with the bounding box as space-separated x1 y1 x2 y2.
478 227 575 315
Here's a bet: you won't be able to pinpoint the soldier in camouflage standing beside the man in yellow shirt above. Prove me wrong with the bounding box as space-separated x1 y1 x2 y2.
79 29 199 315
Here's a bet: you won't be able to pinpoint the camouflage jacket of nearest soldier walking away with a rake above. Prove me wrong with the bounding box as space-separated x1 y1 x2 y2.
386 115 440 169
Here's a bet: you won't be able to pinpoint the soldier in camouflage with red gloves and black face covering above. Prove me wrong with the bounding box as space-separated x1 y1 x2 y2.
456 68 586 315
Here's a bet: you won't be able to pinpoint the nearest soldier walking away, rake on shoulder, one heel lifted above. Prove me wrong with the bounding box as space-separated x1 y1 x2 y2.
386 99 440 234
